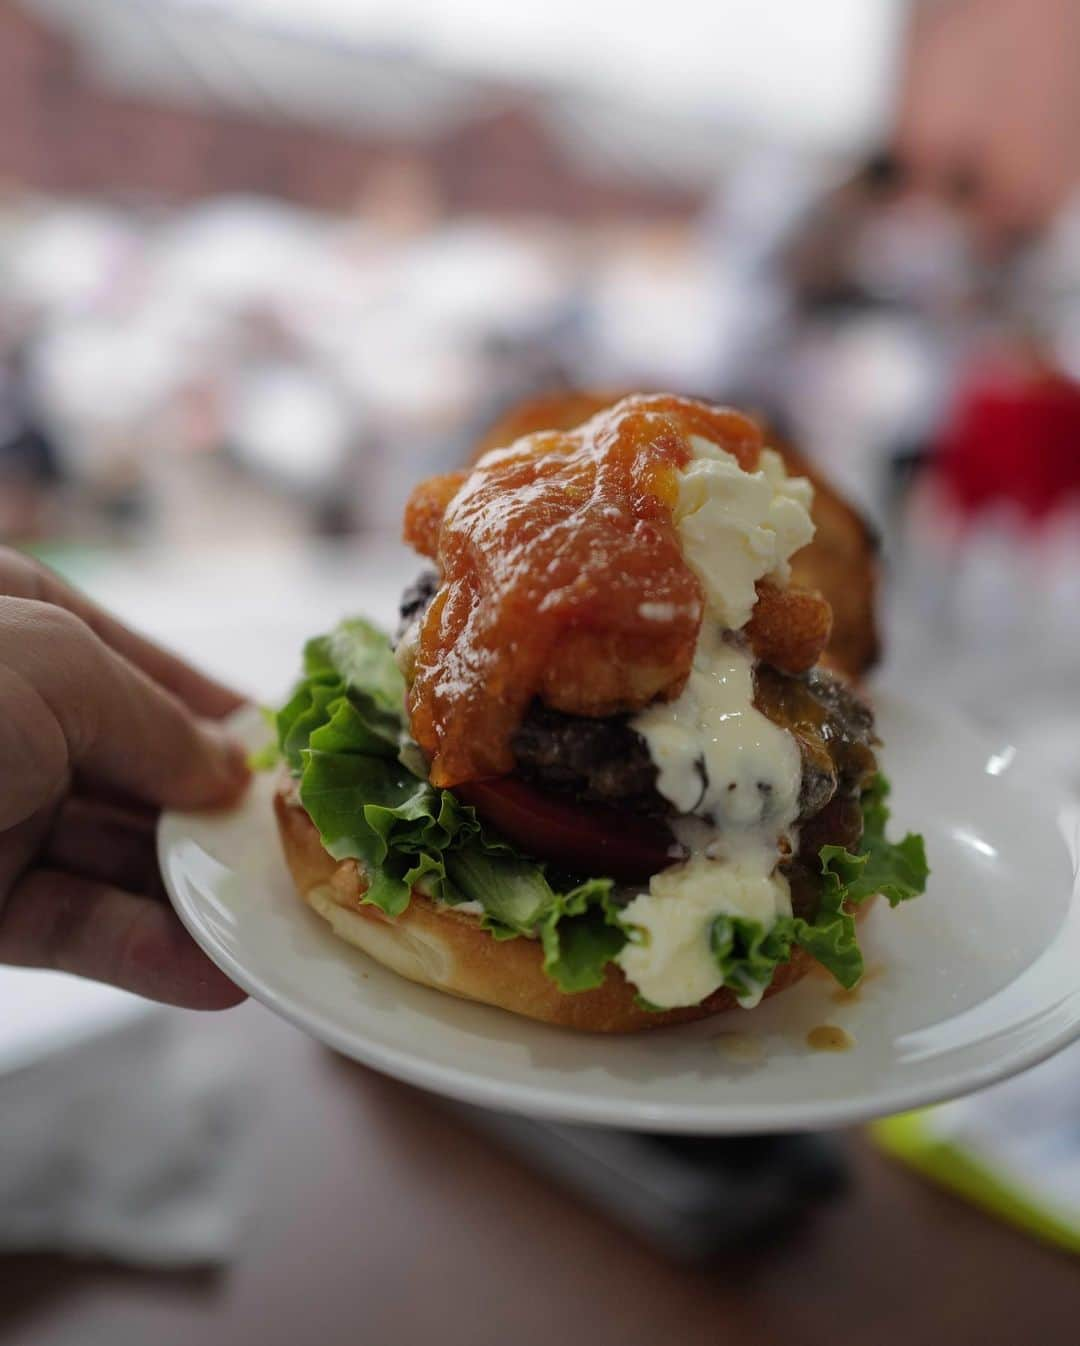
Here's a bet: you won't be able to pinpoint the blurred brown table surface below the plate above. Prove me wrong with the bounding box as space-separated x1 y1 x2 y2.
0 1005 1080 1346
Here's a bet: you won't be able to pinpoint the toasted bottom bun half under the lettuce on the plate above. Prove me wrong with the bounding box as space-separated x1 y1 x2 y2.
273 781 834 1032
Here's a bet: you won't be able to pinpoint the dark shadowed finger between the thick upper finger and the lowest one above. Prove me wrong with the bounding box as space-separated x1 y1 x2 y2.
40 798 164 900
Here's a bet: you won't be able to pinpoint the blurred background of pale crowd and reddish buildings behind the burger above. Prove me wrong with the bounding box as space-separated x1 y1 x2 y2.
0 0 1080 1343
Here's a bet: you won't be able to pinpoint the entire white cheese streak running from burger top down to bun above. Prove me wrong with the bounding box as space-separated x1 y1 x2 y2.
617 437 813 1010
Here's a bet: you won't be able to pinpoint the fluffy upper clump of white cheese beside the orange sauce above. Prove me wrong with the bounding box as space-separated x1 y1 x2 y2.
673 435 813 630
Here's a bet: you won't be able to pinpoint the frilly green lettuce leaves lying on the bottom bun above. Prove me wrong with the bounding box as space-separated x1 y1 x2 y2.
276 618 928 1003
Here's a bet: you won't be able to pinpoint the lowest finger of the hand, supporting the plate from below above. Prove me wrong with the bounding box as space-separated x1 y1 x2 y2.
0 870 244 1010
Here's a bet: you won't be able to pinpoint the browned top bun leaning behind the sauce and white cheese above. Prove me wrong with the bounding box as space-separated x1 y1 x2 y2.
477 389 881 680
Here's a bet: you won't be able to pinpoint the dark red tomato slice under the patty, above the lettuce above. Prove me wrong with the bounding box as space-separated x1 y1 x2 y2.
454 775 675 883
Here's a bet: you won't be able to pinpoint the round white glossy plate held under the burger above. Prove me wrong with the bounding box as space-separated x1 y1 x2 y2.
159 699 1080 1133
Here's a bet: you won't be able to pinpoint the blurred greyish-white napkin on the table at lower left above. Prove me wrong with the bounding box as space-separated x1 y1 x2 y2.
0 969 253 1267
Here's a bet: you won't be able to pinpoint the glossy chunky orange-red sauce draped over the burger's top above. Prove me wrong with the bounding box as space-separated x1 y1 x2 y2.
405 396 761 786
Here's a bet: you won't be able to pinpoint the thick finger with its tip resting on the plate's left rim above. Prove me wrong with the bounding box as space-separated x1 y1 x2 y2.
0 599 249 822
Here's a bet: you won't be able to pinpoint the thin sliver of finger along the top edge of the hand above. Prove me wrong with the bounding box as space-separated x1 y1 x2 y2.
0 552 248 720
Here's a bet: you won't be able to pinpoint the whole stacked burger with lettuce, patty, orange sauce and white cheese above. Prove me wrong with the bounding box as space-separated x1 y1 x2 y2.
275 396 928 1032
